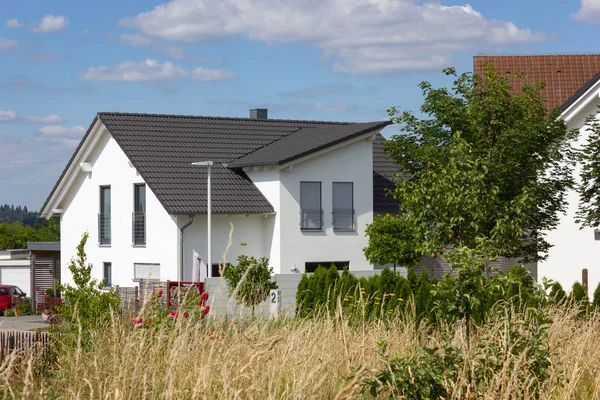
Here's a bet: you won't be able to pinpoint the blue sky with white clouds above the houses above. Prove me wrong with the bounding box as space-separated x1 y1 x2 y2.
0 0 600 209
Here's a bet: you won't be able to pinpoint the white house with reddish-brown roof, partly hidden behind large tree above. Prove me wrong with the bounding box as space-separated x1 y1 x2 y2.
473 54 600 295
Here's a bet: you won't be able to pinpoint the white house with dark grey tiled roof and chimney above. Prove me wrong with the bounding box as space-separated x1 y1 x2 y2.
41 109 398 286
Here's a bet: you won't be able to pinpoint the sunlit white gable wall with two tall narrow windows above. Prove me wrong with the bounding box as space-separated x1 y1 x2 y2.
60 129 179 286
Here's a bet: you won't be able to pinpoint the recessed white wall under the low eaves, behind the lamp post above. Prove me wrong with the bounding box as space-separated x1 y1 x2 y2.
178 214 268 280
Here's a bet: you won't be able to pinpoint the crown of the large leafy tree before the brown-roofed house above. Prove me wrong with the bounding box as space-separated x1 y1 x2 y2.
386 69 577 261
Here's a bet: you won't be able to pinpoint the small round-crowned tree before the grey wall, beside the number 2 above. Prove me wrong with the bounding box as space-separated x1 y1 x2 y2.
224 256 277 315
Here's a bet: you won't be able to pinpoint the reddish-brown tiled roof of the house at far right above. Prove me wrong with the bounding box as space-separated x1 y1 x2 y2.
473 54 600 110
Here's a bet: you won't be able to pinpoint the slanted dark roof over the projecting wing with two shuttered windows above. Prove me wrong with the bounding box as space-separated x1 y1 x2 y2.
230 121 392 168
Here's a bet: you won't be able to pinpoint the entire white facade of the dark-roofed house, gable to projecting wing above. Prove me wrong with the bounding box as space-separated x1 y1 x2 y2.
44 122 384 286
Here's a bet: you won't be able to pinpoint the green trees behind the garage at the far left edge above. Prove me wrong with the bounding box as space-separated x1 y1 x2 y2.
0 220 60 250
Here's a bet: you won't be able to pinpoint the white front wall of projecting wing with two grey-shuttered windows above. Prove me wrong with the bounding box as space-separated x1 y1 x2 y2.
275 139 373 273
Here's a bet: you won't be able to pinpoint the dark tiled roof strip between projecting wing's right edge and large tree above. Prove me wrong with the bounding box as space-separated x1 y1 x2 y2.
373 133 399 214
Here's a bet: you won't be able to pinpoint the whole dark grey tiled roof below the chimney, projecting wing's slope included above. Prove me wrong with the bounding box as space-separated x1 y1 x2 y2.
42 113 390 214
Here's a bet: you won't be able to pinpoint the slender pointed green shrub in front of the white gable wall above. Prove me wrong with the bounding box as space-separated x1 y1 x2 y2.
57 232 120 331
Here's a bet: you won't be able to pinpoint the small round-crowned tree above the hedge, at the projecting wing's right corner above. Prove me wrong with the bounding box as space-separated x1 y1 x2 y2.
363 214 421 272
